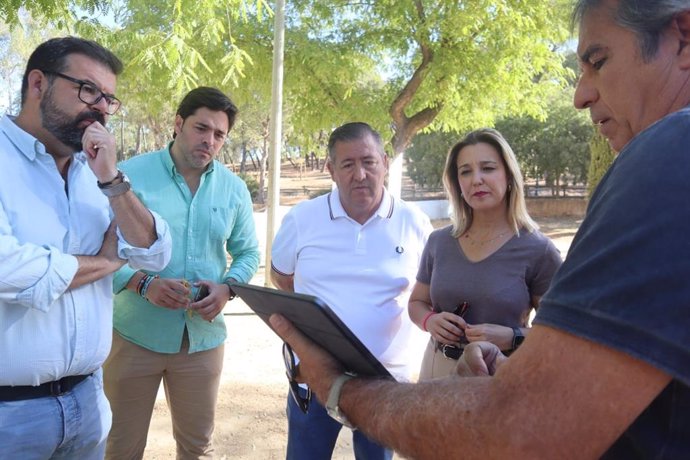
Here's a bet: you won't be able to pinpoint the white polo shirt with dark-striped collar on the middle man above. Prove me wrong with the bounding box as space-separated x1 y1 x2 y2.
271 189 432 381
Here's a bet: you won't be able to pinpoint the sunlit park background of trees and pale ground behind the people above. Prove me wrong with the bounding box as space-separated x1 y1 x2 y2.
0 0 614 459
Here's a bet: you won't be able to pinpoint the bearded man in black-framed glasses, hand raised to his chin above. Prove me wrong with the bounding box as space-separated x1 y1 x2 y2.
0 37 171 459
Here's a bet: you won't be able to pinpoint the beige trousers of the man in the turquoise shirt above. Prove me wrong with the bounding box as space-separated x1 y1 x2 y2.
103 332 224 460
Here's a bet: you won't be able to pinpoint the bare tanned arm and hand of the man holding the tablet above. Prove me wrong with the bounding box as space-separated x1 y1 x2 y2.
270 315 670 459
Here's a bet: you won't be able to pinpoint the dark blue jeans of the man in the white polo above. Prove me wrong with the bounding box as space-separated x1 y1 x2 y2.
286 388 393 460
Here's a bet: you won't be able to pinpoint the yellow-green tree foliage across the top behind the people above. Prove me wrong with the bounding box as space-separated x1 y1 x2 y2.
0 0 573 195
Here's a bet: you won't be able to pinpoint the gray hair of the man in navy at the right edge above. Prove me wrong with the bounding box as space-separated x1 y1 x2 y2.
572 0 690 62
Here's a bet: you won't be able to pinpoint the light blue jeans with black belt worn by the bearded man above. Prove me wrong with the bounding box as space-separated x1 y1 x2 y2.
0 370 110 460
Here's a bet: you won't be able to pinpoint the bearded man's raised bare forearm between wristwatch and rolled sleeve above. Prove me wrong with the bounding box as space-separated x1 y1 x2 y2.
109 190 157 248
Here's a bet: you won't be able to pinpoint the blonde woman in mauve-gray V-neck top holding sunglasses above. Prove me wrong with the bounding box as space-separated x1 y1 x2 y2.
408 129 561 380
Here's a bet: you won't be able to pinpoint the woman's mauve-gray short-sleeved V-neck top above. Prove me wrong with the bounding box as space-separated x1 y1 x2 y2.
417 226 561 327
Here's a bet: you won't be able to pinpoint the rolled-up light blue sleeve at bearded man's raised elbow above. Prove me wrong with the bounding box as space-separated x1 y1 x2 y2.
117 211 172 272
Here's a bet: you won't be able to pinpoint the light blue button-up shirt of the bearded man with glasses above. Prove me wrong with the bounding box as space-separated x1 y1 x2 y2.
0 116 172 386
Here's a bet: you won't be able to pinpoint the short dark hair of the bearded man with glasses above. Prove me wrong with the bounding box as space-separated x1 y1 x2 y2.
22 37 122 105
